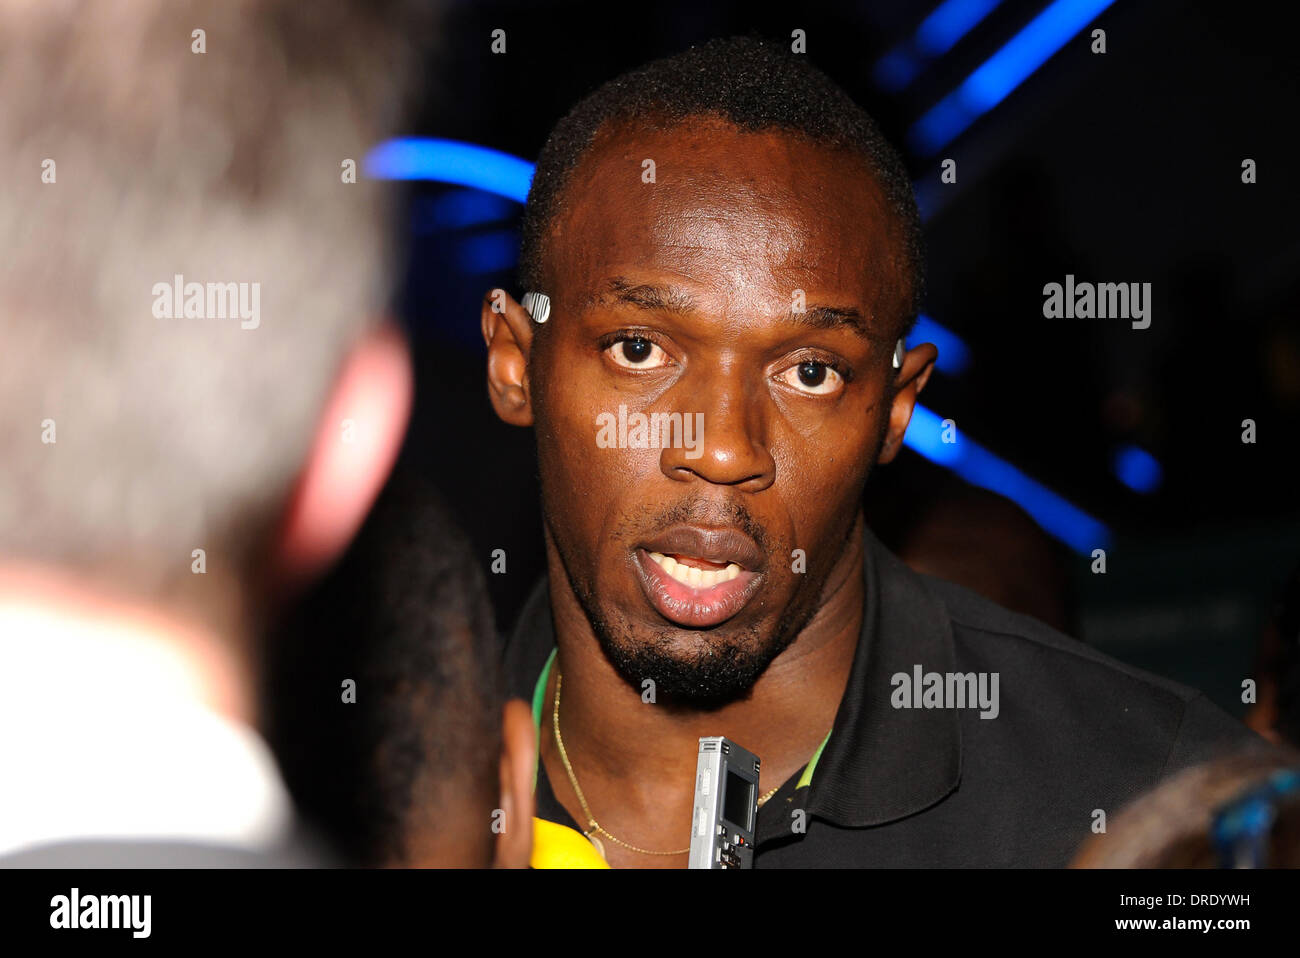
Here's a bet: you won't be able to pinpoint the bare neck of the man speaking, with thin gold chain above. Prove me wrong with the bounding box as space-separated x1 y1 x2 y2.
542 515 863 864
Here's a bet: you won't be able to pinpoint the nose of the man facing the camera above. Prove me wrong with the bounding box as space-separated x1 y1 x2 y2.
659 370 776 493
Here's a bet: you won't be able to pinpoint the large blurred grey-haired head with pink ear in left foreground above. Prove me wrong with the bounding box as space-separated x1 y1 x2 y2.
0 0 431 642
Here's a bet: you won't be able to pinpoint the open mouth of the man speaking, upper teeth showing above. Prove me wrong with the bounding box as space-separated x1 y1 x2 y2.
636 528 766 629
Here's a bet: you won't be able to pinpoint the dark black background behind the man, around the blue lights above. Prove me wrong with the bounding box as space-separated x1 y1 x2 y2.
379 0 1300 714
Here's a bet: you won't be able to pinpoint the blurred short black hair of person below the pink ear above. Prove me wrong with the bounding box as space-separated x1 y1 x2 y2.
265 473 504 866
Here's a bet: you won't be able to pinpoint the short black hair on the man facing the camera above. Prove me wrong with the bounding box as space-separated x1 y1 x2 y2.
520 36 924 331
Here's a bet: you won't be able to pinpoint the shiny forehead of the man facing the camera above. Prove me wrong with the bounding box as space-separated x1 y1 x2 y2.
549 118 900 313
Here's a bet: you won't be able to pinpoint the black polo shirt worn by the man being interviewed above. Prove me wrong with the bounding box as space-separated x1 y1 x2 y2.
506 522 1261 868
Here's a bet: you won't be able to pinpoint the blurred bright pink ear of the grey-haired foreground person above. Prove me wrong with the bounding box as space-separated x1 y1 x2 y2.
273 324 413 586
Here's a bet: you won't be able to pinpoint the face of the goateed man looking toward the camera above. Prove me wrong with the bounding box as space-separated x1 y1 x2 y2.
529 120 906 706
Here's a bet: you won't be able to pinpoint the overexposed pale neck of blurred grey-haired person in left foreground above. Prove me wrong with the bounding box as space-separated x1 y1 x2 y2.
0 565 257 725
